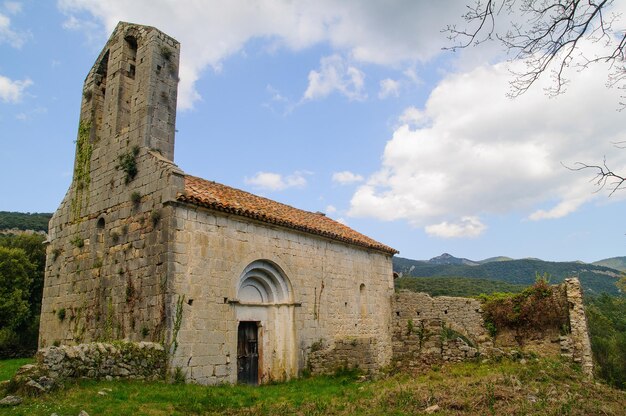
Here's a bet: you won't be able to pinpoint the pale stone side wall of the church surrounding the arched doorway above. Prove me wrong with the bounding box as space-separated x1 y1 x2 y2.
172 205 393 384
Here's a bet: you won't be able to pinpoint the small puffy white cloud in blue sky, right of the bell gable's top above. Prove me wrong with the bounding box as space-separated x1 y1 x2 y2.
302 54 366 100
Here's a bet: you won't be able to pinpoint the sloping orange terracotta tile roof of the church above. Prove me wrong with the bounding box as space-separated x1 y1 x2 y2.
177 175 398 254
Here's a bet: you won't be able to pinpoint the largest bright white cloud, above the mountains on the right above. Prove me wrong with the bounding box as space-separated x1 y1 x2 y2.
349 46 626 237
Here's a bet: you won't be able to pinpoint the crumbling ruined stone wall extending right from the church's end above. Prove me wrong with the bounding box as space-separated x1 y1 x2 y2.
392 278 593 375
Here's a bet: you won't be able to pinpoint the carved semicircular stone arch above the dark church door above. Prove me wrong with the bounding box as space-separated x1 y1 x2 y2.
237 260 292 305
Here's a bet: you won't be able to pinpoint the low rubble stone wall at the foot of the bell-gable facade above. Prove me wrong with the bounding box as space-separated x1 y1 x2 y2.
9 341 167 395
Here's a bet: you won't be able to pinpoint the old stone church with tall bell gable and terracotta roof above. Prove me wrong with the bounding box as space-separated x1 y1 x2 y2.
39 23 397 384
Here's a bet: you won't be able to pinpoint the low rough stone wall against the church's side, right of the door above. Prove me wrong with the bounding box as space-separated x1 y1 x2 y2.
308 337 380 375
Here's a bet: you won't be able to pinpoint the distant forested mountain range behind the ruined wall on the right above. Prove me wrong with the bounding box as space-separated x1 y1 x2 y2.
393 257 621 295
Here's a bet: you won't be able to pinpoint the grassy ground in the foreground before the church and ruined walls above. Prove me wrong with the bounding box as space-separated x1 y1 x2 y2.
1 359 626 416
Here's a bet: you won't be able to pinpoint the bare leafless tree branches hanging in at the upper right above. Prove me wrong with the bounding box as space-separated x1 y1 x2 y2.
445 0 626 195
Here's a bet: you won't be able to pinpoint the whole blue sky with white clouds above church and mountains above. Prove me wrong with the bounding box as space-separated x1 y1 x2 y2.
0 0 626 262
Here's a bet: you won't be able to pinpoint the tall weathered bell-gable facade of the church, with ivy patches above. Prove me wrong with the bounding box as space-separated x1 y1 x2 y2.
39 23 184 347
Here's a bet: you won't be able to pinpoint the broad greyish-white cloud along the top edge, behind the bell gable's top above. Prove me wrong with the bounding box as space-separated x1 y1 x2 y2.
57 0 466 109
